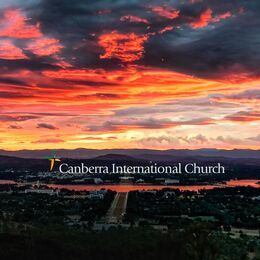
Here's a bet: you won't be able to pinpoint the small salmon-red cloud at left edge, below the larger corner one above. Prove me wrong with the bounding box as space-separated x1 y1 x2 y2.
0 40 27 60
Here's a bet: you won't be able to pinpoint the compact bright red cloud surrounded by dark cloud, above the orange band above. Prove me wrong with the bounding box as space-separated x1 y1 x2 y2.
98 31 148 62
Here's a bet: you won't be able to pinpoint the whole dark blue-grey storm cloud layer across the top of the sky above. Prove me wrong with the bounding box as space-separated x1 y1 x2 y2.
3 0 260 79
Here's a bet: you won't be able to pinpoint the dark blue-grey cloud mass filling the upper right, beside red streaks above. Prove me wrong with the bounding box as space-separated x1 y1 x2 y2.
145 1 260 78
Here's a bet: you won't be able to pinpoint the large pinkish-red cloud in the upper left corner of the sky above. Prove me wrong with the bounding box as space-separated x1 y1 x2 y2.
0 9 42 39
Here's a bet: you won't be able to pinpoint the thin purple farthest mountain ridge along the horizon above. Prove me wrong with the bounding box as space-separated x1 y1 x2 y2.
0 148 260 161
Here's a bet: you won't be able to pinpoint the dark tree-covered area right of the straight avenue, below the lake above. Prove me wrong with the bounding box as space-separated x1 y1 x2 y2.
126 187 260 229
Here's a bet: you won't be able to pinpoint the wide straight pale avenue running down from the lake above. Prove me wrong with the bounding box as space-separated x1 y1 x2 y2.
106 192 128 223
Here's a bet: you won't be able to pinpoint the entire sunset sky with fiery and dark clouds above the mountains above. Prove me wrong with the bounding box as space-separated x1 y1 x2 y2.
0 0 260 150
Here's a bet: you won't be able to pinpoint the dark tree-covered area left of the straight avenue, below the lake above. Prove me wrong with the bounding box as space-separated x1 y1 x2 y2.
0 191 115 225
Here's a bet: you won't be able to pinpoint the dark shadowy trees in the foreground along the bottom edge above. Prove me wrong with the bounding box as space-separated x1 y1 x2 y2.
0 225 257 260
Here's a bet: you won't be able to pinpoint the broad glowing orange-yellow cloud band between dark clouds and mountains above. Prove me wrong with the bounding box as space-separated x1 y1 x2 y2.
0 64 259 149
